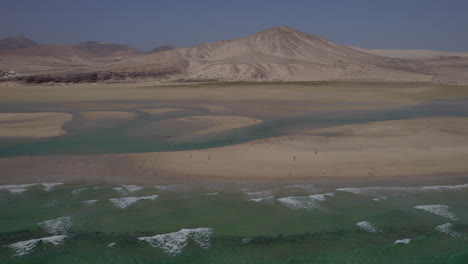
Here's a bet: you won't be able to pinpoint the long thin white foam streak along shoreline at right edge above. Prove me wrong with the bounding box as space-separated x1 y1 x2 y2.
336 183 468 196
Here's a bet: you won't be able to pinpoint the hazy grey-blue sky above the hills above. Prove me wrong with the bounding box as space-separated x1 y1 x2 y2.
0 0 468 51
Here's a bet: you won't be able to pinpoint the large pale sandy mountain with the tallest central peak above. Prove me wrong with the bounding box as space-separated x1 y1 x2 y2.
105 27 431 81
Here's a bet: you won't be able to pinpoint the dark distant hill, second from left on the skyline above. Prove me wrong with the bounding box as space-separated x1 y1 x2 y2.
77 41 143 57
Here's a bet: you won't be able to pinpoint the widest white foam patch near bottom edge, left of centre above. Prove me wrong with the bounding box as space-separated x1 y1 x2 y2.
138 227 213 256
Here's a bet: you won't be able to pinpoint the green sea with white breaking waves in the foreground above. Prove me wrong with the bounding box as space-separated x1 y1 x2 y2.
0 183 468 263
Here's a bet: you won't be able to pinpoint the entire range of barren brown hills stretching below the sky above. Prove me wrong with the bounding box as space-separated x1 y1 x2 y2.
0 26 468 83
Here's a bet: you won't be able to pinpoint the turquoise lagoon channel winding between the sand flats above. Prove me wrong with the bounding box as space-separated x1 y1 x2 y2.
0 100 468 157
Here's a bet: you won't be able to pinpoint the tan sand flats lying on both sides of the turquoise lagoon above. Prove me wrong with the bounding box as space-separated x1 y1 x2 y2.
0 83 468 184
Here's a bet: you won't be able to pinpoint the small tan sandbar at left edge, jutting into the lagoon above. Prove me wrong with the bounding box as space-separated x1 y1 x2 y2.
0 112 72 138
